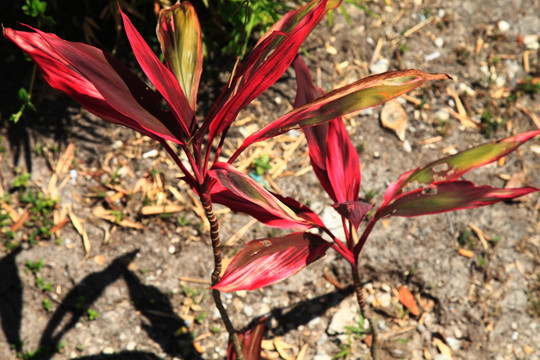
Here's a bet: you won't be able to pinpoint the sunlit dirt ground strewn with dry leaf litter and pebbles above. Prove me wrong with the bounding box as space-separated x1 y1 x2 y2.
0 0 540 360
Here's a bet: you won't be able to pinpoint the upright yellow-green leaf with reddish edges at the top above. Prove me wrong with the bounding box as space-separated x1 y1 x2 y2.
160 1 203 110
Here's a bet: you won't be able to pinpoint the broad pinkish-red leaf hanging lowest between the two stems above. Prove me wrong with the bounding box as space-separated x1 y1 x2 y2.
212 232 331 292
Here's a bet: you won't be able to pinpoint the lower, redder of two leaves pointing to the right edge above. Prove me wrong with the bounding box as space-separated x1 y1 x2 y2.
375 181 538 218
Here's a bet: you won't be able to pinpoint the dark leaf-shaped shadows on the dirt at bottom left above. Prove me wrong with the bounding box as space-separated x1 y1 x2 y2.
0 248 201 360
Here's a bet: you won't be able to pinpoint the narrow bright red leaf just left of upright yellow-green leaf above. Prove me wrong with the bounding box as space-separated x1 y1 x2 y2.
120 10 196 136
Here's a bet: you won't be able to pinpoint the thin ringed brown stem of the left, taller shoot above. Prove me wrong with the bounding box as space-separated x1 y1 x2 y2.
200 191 244 360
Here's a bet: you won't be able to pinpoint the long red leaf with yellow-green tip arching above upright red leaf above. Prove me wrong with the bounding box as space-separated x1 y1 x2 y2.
233 69 450 158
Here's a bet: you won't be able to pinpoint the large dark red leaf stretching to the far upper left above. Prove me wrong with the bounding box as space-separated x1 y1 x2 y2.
4 28 186 144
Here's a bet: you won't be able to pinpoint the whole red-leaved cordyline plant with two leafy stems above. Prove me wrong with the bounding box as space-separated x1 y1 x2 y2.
4 0 536 359
